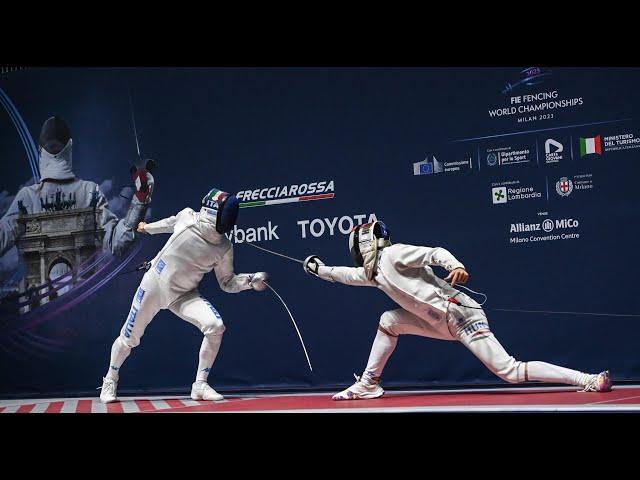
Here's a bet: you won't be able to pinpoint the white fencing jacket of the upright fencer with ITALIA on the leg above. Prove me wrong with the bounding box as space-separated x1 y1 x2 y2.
145 208 251 301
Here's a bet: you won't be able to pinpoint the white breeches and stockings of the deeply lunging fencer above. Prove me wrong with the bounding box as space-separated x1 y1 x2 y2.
365 307 588 386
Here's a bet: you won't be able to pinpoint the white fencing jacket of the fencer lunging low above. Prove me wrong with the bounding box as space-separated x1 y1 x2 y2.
318 243 481 332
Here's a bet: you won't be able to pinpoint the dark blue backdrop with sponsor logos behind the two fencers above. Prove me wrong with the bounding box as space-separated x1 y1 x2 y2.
0 67 640 396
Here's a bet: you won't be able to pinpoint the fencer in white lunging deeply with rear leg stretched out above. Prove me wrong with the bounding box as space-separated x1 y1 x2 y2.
304 221 611 400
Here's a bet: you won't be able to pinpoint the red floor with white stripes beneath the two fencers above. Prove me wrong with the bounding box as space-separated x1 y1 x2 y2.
0 385 640 413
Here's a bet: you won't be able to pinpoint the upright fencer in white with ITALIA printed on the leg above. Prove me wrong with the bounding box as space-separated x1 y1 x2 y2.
100 188 268 403
